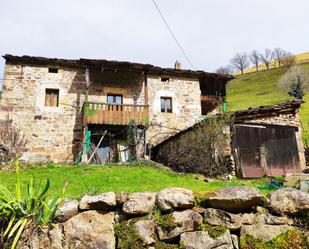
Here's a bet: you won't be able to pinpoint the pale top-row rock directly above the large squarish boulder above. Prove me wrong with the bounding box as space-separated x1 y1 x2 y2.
79 192 116 210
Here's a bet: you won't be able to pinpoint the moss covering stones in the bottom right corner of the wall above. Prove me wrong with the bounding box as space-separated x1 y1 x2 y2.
240 230 309 249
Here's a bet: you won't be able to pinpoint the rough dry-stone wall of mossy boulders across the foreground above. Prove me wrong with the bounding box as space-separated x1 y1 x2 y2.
18 187 309 249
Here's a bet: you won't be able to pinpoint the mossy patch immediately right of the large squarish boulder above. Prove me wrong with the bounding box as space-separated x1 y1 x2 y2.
115 222 143 249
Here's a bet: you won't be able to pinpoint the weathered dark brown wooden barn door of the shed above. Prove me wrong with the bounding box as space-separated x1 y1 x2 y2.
233 124 300 178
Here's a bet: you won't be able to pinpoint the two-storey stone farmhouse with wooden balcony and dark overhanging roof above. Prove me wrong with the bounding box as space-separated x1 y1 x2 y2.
0 55 232 162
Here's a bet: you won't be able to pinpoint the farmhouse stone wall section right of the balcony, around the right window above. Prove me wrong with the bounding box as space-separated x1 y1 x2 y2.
148 76 201 146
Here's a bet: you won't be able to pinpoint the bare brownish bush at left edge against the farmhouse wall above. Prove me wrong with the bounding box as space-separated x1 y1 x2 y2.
0 119 27 163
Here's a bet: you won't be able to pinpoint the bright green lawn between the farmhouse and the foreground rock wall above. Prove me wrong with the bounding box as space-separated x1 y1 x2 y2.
0 165 268 198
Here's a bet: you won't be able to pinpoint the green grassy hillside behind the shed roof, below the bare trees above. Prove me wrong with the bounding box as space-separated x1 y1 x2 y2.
227 64 309 143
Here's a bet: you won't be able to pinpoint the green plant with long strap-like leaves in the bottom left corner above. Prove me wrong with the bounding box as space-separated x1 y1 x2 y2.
0 160 67 249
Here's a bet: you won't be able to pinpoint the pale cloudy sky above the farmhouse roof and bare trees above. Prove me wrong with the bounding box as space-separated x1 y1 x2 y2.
0 0 309 84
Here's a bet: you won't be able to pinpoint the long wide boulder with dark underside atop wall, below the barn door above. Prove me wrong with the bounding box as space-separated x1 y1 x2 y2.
208 186 266 212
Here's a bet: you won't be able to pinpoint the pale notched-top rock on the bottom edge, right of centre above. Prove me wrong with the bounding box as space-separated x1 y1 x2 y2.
180 230 233 249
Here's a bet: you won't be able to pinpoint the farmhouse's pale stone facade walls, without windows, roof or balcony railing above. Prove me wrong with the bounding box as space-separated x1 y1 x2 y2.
0 63 201 162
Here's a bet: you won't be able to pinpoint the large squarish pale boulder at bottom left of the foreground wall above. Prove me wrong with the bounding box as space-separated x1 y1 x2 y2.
63 210 116 249
